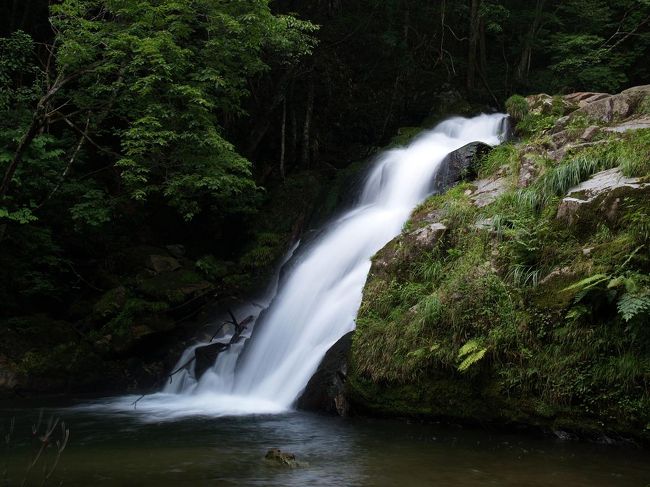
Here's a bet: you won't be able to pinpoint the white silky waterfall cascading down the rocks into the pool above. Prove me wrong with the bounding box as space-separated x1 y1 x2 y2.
90 114 505 419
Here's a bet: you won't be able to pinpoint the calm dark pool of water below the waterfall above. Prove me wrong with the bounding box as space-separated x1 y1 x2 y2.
0 404 650 487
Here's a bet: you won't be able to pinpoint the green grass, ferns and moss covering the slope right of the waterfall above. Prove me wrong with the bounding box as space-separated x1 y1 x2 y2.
351 103 650 434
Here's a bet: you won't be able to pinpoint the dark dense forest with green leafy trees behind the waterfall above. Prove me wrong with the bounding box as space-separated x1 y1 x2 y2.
0 0 650 408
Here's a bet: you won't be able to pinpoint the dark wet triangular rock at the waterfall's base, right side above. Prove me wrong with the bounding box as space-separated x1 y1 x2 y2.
296 331 354 416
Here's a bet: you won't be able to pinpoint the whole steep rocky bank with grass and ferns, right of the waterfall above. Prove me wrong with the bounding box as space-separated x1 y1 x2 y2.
347 86 650 441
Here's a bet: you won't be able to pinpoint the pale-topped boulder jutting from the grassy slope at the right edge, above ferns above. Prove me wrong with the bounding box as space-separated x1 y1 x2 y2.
557 168 650 227
